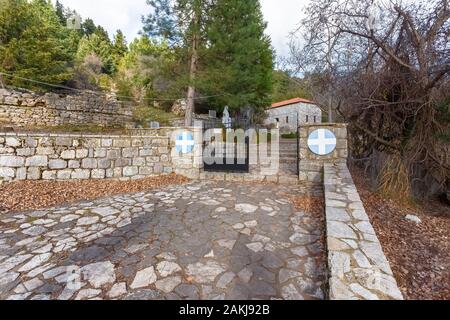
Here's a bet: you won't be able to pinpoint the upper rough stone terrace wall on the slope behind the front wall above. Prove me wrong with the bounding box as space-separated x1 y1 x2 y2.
0 89 133 127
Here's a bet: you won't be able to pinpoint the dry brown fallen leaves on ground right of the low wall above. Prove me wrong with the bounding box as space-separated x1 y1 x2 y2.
353 172 450 300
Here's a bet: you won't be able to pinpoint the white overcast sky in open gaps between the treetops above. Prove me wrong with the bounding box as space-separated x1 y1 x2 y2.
50 0 309 55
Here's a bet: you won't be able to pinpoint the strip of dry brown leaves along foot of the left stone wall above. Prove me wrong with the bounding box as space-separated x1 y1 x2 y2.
0 174 188 213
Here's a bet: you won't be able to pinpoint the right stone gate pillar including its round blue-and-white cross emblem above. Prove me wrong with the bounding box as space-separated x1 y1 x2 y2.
298 123 348 183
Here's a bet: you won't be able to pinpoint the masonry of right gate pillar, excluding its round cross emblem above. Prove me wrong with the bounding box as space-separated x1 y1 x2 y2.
299 123 348 183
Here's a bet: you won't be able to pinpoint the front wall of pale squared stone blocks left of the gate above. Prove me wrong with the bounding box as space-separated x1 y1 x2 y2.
0 130 174 181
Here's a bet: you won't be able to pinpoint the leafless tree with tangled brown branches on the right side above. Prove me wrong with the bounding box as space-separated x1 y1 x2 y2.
291 0 450 199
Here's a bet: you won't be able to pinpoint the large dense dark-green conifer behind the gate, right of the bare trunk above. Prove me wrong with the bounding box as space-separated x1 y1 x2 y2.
201 0 273 110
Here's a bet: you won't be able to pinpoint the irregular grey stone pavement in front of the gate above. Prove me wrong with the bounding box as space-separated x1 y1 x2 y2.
0 182 325 300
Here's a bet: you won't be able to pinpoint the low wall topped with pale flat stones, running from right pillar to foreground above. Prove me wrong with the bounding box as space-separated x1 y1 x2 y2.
324 163 403 300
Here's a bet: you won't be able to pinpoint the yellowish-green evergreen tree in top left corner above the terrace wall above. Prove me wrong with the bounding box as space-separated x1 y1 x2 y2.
0 0 75 89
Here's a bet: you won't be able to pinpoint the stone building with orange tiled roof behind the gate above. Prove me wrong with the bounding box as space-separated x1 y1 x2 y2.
266 98 322 133
